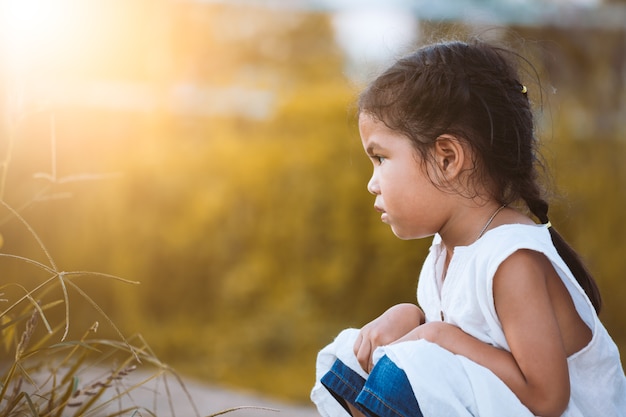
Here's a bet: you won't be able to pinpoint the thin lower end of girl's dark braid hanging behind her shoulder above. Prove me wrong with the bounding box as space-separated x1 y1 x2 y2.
526 199 602 313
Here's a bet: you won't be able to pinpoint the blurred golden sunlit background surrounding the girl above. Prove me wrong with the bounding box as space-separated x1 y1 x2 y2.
0 0 626 402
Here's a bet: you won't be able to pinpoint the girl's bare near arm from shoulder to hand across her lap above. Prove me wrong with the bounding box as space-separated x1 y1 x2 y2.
402 250 570 417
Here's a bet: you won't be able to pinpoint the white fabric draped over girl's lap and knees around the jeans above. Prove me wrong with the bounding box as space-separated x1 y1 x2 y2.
311 329 532 417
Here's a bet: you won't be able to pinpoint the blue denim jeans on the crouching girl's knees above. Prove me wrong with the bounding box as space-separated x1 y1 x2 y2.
320 356 423 417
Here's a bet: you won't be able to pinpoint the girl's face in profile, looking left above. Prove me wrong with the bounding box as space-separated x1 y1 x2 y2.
359 113 445 239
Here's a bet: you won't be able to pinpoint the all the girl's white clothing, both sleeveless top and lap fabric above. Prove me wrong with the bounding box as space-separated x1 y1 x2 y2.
311 225 626 417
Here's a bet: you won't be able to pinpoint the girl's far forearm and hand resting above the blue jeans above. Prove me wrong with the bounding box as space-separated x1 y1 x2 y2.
354 303 425 373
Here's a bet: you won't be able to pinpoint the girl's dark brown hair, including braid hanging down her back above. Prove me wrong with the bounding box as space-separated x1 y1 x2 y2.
358 40 602 312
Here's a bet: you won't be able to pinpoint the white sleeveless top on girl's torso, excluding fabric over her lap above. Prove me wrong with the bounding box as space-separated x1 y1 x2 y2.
414 224 626 417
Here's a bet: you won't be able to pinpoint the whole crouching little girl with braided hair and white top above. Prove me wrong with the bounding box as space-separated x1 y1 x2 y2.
311 40 626 417
